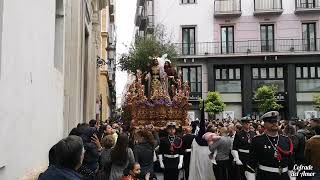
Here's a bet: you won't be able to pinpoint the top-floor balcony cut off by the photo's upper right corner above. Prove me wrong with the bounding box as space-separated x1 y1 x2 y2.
295 0 320 14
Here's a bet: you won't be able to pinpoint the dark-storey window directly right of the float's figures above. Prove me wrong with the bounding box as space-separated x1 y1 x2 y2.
179 66 202 97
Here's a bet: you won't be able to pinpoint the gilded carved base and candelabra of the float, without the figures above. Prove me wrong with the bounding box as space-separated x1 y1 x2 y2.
125 64 190 127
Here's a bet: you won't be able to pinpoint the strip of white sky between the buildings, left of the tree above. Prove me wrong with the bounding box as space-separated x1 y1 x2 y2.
116 0 137 104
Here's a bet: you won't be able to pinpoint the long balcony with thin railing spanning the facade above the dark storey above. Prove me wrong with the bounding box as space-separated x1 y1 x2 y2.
174 38 320 57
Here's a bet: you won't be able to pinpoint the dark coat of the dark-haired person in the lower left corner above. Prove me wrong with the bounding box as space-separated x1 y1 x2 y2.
38 166 83 180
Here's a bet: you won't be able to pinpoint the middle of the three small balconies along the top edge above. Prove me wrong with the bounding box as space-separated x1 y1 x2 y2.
253 0 283 16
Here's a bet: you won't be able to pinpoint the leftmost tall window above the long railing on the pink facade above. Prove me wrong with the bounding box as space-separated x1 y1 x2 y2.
182 27 196 55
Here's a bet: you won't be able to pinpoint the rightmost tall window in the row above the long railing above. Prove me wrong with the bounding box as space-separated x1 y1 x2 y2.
302 23 316 51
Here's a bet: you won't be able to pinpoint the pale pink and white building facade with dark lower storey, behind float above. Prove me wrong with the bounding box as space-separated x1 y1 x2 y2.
136 0 320 119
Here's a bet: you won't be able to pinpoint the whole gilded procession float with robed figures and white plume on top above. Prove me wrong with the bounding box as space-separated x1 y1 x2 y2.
123 55 191 128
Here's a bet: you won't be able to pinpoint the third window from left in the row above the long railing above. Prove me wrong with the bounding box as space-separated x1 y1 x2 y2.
260 24 274 52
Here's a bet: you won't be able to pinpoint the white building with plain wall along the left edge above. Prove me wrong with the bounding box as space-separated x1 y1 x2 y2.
0 0 106 180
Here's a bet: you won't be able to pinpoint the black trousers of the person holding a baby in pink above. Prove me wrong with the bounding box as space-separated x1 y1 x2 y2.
213 160 231 180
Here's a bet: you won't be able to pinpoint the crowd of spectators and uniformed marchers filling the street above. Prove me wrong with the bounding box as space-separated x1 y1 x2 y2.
39 111 320 180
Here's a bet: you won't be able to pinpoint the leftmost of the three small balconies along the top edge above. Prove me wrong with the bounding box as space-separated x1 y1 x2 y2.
214 0 241 18
